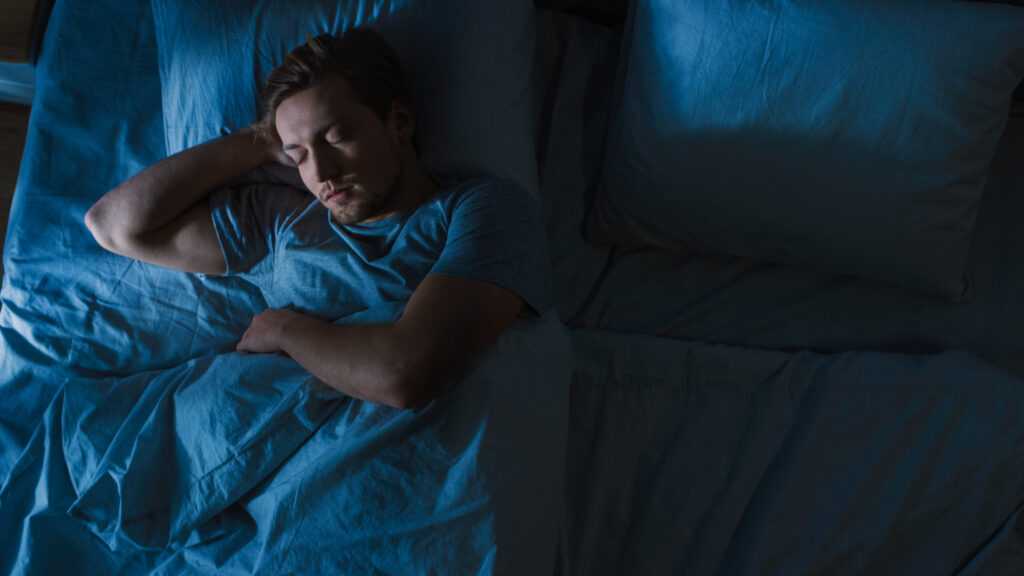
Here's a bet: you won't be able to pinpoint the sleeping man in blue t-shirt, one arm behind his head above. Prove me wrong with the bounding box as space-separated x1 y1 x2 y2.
85 29 551 408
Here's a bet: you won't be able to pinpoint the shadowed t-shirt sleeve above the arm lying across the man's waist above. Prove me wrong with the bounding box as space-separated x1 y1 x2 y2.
430 180 553 316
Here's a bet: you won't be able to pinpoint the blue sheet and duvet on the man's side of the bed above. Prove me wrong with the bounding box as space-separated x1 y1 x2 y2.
0 0 570 574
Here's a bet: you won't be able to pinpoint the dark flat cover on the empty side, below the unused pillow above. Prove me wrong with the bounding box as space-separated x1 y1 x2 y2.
564 331 1024 576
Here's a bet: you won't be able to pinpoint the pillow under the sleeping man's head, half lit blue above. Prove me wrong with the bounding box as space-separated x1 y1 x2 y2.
152 0 537 192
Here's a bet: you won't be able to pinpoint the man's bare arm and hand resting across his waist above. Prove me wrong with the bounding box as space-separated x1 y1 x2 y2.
238 275 524 408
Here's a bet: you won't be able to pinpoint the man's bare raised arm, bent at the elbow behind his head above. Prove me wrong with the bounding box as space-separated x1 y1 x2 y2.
85 129 280 274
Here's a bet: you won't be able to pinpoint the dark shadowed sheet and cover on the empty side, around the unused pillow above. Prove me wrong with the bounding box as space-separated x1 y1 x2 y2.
542 17 1024 576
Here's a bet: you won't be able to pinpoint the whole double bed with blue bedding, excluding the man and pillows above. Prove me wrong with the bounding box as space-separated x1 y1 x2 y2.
0 0 1024 575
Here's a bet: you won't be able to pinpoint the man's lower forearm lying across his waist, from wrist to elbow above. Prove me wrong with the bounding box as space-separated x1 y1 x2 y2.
280 314 415 408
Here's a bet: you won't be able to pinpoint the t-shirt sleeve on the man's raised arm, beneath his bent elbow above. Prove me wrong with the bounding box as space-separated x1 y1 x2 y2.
209 184 301 280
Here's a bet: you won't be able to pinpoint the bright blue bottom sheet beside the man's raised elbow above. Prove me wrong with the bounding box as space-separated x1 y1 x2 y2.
0 1 263 487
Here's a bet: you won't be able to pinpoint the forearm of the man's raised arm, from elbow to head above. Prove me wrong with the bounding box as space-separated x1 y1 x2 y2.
86 129 271 237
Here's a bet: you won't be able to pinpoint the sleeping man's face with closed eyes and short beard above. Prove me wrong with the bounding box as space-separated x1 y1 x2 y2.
275 75 401 224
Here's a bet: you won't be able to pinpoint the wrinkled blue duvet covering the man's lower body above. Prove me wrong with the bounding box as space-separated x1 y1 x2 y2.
0 306 570 574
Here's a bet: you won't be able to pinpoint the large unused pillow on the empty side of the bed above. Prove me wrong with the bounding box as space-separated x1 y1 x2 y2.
587 0 1024 299
